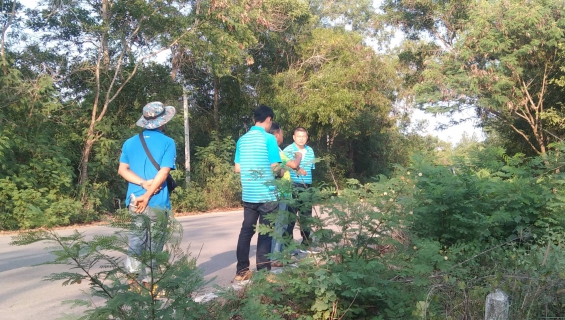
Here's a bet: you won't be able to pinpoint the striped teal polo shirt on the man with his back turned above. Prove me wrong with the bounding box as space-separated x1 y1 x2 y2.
235 126 281 203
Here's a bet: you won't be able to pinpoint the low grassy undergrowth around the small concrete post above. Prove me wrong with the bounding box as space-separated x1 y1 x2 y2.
413 239 565 319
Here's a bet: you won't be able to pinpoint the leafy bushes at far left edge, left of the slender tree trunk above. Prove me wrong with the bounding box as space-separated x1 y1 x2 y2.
0 66 97 230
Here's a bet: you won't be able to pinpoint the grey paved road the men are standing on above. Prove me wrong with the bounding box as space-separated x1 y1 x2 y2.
0 210 256 320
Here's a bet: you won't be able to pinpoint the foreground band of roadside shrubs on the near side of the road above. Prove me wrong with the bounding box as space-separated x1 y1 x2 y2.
14 145 565 319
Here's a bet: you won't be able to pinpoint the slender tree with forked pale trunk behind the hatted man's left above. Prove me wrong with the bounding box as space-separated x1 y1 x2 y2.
29 0 199 189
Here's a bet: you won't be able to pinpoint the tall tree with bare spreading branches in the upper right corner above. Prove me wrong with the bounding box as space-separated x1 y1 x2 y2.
384 0 565 154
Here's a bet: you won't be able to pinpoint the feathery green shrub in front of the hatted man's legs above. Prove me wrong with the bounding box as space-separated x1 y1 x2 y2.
11 210 207 320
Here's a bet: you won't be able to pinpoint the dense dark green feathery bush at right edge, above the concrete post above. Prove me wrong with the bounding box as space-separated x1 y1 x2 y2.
407 148 565 246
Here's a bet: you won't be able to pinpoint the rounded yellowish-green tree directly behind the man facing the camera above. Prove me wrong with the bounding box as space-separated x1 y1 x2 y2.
272 28 399 176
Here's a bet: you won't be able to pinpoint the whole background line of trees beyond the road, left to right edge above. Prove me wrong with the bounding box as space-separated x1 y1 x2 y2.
0 0 565 228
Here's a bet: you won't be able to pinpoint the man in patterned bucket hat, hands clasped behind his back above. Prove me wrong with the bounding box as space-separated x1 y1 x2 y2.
118 102 176 284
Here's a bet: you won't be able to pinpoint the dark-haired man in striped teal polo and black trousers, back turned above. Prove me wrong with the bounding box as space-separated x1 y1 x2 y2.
234 105 281 281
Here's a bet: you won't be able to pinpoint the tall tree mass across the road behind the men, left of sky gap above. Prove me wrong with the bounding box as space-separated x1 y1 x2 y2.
0 0 437 230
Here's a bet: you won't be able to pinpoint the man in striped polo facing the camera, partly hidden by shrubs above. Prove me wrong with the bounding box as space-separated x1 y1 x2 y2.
283 127 315 247
